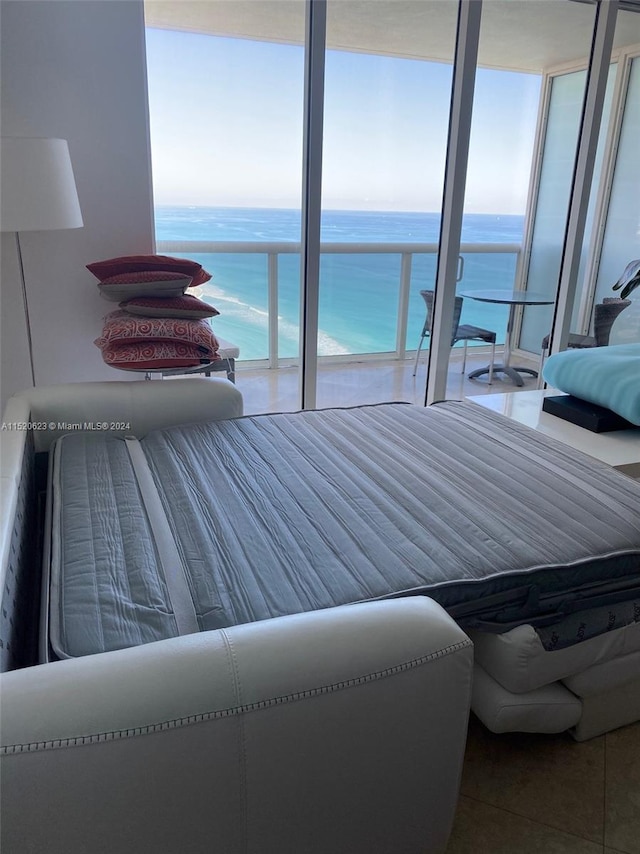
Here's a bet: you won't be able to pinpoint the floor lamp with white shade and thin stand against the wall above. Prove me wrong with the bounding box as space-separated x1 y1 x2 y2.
0 137 82 386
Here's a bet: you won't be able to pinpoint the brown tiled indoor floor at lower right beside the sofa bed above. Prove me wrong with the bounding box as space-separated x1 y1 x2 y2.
447 716 640 854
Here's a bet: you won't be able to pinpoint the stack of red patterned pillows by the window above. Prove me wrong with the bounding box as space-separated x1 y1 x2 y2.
87 255 220 371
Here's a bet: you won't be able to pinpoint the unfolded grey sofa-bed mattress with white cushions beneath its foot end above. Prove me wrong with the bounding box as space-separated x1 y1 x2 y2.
3 380 640 739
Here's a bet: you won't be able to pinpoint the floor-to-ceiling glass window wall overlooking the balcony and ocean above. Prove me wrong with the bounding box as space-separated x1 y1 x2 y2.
146 0 640 409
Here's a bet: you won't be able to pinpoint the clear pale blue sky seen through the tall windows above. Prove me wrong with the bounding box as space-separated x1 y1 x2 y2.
147 29 540 214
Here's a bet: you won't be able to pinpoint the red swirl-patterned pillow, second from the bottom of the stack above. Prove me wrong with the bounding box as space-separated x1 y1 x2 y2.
95 311 219 358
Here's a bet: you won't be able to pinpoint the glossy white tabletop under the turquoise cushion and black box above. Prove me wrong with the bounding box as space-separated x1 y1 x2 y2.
467 389 640 477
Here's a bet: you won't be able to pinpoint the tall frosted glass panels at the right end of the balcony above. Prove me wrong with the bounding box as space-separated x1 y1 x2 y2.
520 4 640 352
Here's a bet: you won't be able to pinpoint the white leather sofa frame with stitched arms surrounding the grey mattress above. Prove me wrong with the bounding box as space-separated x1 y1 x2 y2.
0 377 473 854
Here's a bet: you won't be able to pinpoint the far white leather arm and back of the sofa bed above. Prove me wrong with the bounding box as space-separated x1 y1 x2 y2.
0 377 242 670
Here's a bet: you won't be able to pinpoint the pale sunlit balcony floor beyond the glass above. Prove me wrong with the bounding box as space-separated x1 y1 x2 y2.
230 351 537 415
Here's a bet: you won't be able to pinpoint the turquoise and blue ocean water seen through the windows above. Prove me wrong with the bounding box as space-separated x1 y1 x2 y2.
155 206 524 359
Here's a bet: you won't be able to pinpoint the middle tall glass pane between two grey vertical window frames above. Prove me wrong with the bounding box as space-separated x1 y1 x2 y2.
317 0 456 405
